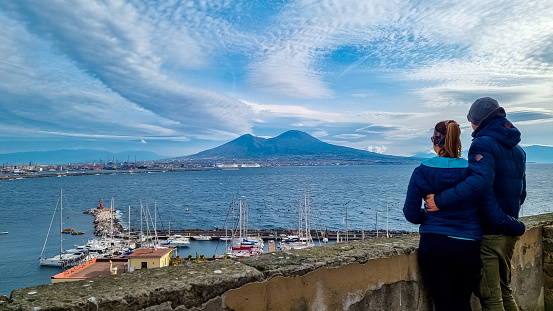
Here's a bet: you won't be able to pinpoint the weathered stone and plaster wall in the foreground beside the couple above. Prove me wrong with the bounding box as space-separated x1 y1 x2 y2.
0 214 553 311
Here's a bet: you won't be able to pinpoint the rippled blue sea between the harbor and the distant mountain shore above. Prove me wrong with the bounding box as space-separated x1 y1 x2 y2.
0 163 553 296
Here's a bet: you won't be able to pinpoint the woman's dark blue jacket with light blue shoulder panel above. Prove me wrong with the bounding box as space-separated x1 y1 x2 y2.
403 157 525 240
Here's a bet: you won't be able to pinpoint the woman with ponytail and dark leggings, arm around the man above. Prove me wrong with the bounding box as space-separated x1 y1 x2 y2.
403 120 525 311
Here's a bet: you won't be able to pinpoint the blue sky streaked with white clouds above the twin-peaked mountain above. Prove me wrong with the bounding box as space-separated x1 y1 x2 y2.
0 0 553 156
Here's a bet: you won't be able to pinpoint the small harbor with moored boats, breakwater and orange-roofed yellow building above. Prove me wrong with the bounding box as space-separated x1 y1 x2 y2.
27 199 408 283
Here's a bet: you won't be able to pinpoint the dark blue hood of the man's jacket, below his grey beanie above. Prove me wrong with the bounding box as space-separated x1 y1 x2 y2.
472 107 520 148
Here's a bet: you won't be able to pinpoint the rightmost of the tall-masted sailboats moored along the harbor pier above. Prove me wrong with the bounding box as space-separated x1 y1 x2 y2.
279 191 315 251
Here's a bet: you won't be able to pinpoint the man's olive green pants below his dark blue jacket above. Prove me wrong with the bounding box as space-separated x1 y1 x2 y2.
478 235 518 311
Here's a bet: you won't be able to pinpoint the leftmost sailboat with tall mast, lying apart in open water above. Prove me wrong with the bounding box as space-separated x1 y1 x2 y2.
40 189 88 268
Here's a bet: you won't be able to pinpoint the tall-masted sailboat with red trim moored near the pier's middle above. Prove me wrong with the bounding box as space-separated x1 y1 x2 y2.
227 198 263 257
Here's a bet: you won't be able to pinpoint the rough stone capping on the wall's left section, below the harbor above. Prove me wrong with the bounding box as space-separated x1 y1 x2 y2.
4 260 263 310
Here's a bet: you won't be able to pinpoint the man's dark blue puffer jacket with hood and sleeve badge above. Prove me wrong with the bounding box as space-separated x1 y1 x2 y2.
434 107 526 234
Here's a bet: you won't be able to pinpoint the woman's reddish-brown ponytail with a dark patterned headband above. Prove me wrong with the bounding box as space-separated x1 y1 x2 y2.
432 120 461 158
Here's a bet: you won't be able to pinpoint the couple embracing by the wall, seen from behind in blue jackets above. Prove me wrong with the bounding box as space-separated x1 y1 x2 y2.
403 97 526 311
